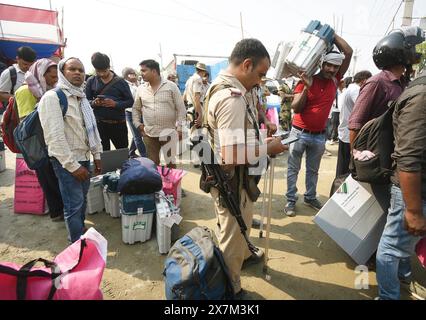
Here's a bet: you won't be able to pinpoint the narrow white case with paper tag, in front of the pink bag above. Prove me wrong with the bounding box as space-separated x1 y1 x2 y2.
155 191 182 254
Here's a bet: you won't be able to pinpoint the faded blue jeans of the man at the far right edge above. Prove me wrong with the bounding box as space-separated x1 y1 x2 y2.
376 186 426 300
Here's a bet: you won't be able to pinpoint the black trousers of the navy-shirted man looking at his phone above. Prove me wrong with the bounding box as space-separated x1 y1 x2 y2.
97 120 129 151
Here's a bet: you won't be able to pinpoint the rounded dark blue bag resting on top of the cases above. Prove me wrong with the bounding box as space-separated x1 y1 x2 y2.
118 158 162 194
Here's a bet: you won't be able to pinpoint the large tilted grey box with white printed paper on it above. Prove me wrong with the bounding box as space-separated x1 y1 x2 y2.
314 176 389 265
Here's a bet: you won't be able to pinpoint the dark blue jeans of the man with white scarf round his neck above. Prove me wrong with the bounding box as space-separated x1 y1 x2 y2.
50 158 90 242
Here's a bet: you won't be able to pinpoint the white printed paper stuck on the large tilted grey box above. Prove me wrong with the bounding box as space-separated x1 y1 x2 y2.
332 176 372 218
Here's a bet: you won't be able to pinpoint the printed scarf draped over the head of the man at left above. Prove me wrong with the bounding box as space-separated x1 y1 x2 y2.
25 58 57 99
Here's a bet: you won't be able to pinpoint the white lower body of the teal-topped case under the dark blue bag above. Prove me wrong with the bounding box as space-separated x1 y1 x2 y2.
121 212 154 244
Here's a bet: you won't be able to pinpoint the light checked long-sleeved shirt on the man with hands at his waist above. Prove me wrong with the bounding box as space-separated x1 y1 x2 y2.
132 79 186 137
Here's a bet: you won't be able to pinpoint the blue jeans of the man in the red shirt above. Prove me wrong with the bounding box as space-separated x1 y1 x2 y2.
286 127 325 204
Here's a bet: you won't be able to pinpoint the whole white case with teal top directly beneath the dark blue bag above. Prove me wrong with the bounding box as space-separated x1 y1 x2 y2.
121 193 155 244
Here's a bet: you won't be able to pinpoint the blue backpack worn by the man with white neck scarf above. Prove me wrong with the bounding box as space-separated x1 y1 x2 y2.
13 88 68 170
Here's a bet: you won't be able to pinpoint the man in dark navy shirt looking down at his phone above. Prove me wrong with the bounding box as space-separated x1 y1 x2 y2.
85 52 134 151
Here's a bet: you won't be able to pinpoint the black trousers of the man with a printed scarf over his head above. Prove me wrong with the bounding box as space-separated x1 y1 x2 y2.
35 161 64 218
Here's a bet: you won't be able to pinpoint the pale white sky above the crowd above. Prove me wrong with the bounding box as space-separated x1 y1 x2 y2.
0 0 426 73
